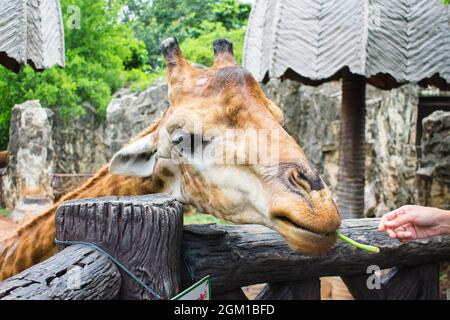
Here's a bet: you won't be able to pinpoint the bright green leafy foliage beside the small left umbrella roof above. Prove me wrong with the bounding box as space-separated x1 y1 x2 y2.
0 0 148 150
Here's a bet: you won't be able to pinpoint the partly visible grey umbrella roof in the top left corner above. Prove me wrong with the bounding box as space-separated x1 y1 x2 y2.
0 0 65 72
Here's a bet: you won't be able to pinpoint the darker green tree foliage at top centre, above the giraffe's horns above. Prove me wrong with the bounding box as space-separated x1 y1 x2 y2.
125 0 251 70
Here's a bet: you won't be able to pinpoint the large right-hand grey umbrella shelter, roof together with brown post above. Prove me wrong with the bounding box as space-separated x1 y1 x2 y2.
244 0 450 218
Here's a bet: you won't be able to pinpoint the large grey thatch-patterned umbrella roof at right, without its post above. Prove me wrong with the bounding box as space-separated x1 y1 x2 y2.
243 0 450 88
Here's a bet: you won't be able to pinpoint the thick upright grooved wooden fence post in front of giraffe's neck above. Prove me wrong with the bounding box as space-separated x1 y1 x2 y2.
56 194 183 300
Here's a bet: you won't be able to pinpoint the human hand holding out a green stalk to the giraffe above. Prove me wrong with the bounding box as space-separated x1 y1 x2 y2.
378 205 450 240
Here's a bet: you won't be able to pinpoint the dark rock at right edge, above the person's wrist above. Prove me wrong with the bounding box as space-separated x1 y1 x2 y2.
417 111 450 210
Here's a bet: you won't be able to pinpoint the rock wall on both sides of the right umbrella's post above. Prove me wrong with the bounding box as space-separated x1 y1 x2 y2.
264 80 419 216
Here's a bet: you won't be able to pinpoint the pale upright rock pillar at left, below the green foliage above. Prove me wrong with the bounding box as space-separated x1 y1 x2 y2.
3 100 53 221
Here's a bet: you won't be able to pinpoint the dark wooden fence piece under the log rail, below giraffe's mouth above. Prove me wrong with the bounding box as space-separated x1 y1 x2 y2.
256 279 320 300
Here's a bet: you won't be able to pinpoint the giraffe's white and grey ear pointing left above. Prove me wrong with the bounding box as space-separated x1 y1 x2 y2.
109 134 158 177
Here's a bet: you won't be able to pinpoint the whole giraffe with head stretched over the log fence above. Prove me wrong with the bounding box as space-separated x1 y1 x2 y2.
0 38 340 279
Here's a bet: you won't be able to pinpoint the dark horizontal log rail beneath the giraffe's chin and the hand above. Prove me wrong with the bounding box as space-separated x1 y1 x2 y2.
183 219 450 294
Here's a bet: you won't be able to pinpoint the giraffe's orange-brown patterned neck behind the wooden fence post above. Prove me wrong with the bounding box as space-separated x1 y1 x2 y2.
0 166 164 281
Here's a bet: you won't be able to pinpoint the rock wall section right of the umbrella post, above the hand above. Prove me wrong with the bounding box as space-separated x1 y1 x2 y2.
364 85 419 216
